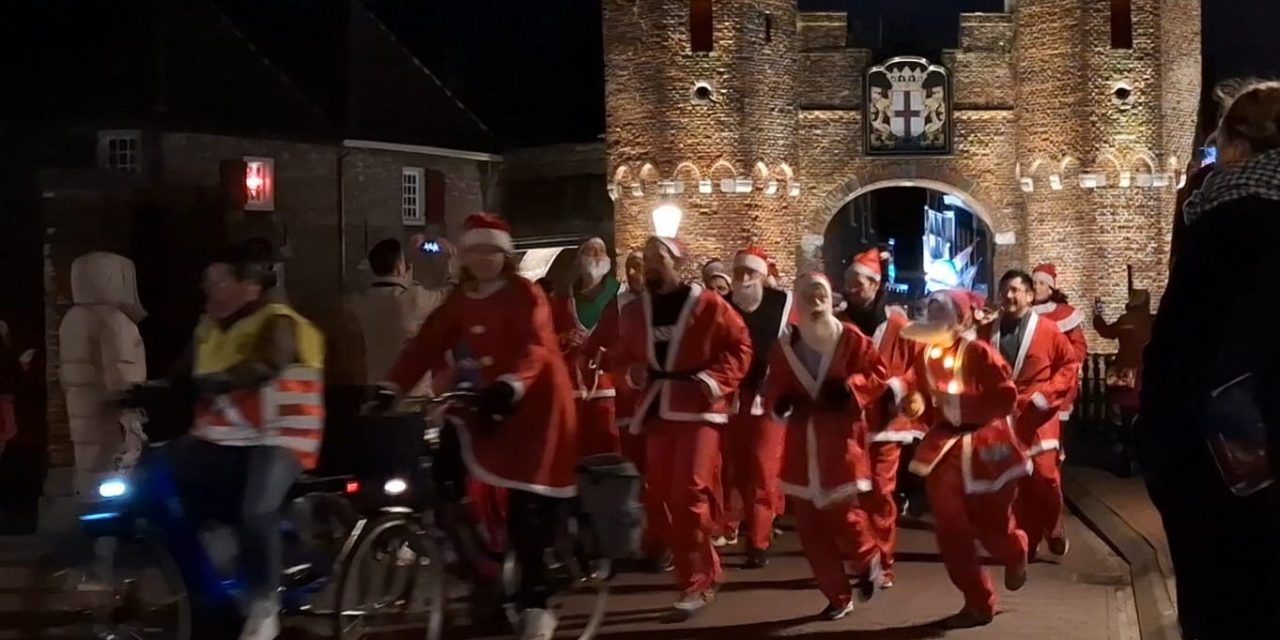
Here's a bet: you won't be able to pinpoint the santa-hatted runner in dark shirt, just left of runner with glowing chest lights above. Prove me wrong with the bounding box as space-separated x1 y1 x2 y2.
845 247 924 589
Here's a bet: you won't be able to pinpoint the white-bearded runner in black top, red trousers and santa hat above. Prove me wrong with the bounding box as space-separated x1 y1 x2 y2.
723 247 791 568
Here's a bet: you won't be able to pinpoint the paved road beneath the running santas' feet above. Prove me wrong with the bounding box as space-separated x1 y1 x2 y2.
0 506 1139 640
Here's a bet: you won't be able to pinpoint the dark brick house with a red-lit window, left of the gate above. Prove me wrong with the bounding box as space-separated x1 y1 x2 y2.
0 0 500 466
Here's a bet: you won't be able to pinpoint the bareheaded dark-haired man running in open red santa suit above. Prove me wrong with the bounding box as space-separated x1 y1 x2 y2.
980 271 1080 558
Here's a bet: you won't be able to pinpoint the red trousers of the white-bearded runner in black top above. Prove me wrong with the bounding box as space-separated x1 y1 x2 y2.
721 413 786 549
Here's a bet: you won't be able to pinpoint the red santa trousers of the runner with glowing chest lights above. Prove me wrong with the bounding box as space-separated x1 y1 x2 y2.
924 447 1027 616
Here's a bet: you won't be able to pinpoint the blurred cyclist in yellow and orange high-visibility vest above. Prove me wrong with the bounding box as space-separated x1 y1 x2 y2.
158 247 324 640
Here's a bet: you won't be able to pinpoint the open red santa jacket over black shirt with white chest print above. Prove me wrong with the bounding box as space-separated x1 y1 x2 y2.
609 283 751 433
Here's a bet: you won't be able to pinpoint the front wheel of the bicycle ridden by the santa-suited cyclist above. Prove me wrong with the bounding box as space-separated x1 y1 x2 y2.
334 516 445 640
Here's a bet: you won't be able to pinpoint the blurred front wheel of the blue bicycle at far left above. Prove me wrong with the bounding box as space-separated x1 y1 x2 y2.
61 538 192 640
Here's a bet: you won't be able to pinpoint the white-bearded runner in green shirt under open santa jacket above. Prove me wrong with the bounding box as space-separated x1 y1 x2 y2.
550 238 620 458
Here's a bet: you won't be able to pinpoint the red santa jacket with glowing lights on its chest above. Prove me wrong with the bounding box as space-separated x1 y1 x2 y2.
902 338 1032 494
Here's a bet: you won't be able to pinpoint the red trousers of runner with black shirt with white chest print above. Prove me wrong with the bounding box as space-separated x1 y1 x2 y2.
644 420 723 593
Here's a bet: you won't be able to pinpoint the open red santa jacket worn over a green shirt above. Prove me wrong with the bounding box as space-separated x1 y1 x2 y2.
550 286 618 399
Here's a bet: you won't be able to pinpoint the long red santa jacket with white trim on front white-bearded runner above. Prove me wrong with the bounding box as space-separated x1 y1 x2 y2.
765 323 887 508
